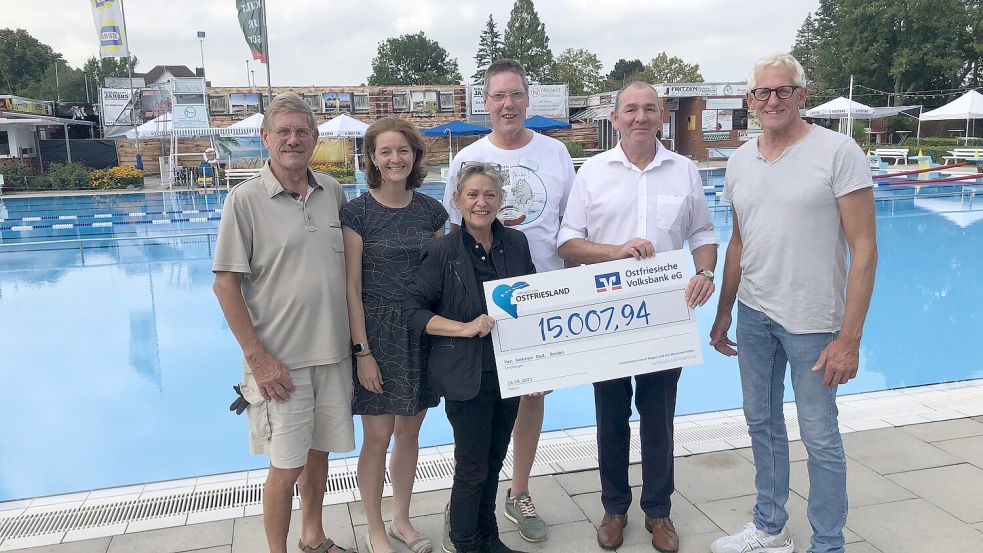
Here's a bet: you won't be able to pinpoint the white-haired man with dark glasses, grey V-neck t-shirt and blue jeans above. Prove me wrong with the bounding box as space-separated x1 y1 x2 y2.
710 54 877 553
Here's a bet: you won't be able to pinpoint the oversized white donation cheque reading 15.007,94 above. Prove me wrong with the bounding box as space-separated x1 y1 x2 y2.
485 250 703 397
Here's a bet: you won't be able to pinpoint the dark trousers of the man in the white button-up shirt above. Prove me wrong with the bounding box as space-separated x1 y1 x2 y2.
594 369 681 518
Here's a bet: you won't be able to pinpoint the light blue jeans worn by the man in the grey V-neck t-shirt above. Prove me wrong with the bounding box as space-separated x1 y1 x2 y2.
737 302 847 553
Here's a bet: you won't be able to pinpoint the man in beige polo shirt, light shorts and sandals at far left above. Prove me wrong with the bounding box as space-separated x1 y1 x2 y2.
212 93 355 553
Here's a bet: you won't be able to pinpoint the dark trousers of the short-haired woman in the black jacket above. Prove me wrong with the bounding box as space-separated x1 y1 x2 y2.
444 373 519 553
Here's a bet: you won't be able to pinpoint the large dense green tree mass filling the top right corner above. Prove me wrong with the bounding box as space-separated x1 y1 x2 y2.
792 0 983 105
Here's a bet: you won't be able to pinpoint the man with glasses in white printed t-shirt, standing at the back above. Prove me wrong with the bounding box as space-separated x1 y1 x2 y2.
444 60 575 545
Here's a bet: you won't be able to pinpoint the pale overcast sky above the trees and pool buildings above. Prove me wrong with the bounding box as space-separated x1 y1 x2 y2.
11 0 819 86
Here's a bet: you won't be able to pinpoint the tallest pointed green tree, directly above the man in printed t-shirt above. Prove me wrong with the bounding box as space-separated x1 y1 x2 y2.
502 0 553 82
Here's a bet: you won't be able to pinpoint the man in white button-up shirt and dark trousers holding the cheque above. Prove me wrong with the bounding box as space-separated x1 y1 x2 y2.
557 82 717 552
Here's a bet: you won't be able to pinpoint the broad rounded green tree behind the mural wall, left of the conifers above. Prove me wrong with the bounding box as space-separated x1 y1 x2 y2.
369 31 461 86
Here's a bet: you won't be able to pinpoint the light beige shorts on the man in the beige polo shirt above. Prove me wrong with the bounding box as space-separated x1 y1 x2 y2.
241 359 355 469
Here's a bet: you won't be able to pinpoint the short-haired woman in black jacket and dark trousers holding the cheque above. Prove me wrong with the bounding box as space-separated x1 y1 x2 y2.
405 164 536 553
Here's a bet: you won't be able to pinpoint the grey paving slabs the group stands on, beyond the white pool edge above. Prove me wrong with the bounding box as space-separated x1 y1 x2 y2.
11 417 983 553
